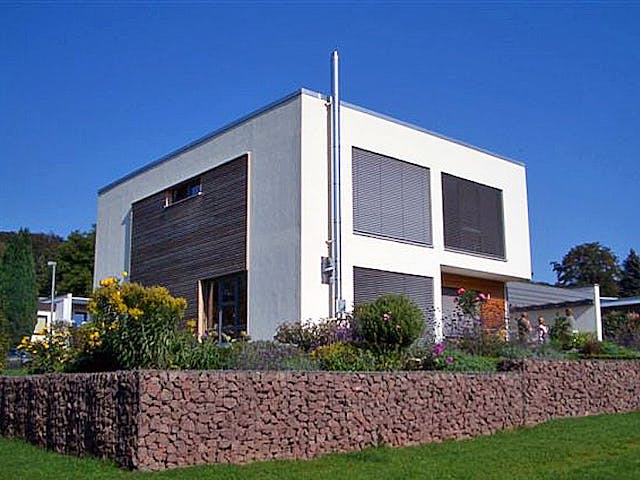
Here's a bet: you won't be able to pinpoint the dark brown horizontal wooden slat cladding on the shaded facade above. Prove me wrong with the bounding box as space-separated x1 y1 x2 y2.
130 155 248 318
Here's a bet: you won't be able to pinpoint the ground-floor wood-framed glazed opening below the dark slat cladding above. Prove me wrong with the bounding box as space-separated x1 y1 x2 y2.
201 272 247 338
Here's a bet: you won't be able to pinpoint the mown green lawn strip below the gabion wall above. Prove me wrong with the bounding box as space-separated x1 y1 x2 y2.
0 413 640 480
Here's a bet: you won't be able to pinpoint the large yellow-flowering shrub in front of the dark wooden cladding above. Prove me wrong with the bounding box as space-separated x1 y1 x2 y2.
89 277 186 369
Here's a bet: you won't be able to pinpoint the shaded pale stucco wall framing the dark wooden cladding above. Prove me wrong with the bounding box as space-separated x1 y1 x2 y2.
94 96 301 338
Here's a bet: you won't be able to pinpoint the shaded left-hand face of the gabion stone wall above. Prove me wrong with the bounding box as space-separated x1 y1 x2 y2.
0 372 140 468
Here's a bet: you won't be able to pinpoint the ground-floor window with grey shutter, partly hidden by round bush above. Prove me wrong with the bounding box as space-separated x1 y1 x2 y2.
353 267 433 319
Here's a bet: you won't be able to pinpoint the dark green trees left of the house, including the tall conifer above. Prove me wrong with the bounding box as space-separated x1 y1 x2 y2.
0 227 95 354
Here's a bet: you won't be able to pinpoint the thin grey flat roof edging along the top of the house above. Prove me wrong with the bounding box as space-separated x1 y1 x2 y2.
98 88 524 195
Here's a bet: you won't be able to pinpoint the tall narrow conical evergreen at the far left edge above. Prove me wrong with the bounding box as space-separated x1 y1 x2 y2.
0 230 37 345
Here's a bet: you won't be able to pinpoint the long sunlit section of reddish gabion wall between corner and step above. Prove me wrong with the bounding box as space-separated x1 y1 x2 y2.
138 372 522 469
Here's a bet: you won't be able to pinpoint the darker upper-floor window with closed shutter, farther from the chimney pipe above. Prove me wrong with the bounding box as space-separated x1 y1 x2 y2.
442 173 505 258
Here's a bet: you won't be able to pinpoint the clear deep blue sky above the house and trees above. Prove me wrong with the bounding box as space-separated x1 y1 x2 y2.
0 2 640 281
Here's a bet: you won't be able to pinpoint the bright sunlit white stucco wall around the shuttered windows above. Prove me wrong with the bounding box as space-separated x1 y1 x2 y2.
301 96 531 330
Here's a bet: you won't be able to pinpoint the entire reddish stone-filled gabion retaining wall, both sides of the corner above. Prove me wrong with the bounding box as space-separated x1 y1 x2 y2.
0 361 640 470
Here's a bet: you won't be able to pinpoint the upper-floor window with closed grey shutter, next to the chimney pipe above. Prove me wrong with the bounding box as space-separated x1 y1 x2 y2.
352 147 431 245
